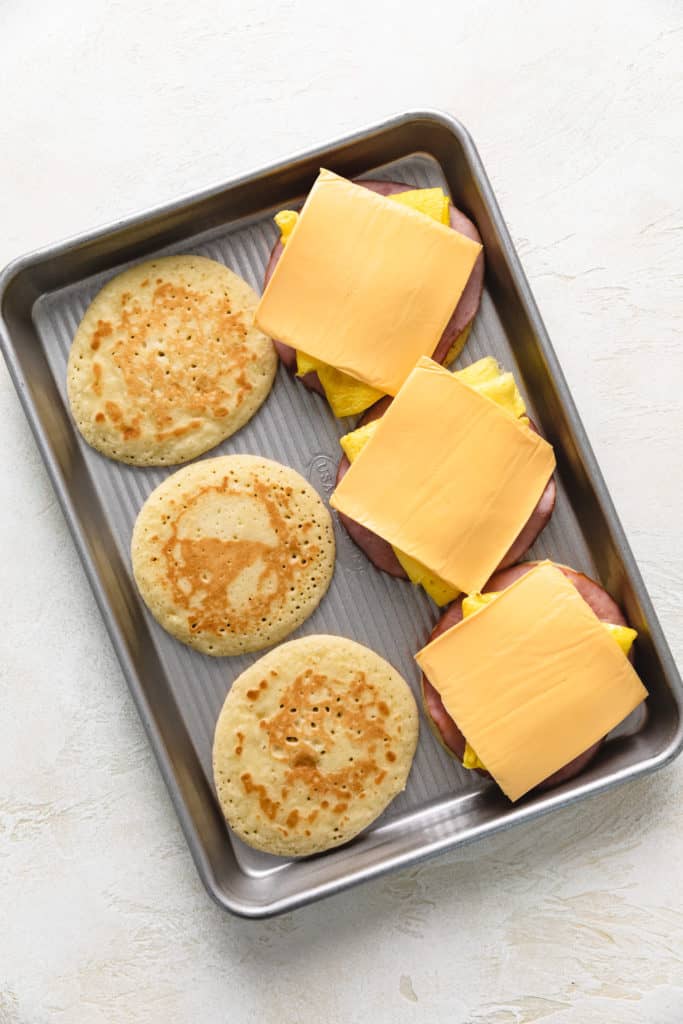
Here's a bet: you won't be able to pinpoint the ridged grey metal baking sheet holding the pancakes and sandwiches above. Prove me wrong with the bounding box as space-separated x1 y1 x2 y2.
0 112 683 918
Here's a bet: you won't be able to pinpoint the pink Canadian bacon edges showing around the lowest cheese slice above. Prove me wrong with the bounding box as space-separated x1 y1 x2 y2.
422 562 632 791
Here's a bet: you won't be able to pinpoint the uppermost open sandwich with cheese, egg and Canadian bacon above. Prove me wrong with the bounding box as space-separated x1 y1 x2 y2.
256 170 483 416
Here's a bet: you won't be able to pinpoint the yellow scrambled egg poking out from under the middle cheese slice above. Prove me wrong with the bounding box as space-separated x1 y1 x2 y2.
339 355 528 606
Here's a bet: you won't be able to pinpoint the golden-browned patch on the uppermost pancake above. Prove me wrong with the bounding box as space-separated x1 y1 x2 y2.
102 278 257 441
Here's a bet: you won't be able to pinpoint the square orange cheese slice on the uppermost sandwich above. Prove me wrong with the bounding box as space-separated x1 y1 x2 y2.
255 171 481 394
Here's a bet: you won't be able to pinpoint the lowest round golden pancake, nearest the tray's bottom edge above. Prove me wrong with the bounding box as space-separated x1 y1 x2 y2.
213 636 418 857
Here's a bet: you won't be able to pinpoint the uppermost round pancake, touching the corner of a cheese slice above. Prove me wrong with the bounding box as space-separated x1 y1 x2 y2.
67 256 278 466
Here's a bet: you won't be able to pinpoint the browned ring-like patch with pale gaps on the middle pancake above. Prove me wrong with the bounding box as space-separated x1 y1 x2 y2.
162 476 319 634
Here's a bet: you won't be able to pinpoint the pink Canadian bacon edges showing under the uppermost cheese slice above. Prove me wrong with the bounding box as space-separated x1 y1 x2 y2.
263 179 484 395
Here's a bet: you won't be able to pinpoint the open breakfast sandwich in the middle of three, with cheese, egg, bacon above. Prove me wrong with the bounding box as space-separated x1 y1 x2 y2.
330 356 555 605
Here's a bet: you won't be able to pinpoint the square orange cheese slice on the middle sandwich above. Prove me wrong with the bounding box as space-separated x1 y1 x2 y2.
330 356 555 593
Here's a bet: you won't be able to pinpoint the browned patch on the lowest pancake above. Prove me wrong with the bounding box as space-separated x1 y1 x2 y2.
240 669 395 834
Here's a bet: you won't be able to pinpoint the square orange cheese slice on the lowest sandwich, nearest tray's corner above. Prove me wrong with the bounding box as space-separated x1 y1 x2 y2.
416 562 647 800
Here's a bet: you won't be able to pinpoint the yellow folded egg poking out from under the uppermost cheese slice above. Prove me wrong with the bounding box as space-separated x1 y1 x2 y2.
274 188 454 417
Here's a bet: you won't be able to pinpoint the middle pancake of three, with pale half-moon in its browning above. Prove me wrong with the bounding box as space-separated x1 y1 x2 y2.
131 455 335 655
